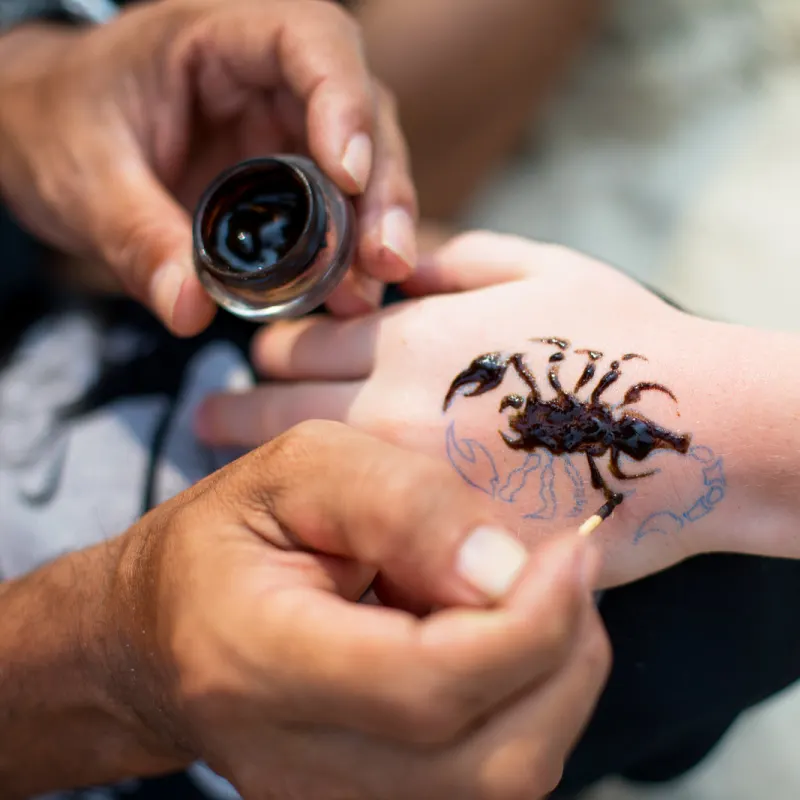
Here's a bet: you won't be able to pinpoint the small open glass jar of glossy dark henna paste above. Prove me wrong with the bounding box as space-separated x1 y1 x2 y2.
193 155 356 322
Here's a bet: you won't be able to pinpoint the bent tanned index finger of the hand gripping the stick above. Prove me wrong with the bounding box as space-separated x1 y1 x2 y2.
260 537 591 744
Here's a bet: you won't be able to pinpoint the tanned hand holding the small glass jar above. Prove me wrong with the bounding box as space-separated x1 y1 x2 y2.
0 0 416 335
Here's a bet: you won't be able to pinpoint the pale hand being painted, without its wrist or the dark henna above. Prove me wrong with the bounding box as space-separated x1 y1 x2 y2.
198 233 724 585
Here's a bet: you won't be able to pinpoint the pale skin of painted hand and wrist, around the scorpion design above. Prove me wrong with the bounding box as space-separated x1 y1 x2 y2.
197 233 800 586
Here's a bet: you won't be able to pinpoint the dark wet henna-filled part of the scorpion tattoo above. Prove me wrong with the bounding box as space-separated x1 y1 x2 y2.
444 337 692 520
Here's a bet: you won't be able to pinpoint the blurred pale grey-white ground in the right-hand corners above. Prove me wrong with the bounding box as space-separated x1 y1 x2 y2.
450 0 800 800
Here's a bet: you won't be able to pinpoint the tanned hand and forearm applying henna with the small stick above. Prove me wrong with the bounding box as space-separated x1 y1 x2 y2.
0 422 609 800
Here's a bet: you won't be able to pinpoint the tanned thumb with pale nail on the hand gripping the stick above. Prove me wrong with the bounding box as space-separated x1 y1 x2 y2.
231 421 528 605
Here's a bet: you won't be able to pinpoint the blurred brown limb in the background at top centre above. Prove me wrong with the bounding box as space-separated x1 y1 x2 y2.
359 0 605 216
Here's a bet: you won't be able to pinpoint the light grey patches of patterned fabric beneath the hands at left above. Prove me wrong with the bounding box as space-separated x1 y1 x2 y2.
0 304 250 800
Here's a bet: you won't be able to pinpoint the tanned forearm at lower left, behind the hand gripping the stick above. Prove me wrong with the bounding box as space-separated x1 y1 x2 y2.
0 540 176 800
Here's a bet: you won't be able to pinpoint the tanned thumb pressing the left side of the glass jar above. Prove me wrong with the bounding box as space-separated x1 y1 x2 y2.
90 148 215 336
